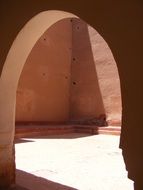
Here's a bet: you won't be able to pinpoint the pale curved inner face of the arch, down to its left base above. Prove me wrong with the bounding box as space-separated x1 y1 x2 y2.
0 11 121 185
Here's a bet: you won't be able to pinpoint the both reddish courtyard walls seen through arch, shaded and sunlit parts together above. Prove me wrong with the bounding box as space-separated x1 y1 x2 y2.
16 19 121 123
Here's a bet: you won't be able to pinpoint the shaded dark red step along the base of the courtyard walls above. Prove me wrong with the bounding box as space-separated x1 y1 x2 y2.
15 125 98 139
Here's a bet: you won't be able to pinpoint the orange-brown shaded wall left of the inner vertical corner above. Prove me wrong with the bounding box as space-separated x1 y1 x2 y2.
16 19 72 122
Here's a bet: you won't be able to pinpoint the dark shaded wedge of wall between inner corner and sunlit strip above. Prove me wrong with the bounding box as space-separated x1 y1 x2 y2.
70 19 105 120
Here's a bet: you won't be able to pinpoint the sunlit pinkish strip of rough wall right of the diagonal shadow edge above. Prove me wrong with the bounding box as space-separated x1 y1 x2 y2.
88 25 122 125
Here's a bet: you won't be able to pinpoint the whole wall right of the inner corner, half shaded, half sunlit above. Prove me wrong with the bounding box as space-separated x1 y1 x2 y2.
71 19 121 125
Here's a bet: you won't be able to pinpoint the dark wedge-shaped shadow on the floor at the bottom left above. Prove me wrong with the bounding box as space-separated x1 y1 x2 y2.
16 170 78 190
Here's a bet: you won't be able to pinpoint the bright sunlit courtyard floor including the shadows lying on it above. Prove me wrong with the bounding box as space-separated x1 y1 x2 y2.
14 134 133 190
